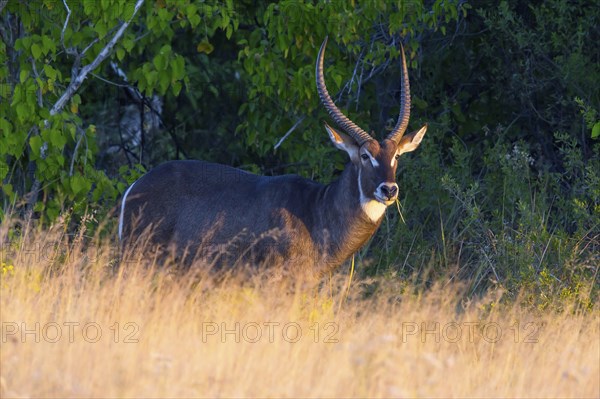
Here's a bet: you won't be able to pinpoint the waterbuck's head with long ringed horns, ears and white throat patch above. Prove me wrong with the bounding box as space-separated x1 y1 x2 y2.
316 38 427 222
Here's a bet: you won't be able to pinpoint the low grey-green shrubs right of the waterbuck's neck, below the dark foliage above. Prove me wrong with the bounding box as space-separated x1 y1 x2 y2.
363 127 600 308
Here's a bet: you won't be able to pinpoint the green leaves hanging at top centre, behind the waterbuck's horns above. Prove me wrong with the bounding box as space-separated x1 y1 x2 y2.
236 0 467 176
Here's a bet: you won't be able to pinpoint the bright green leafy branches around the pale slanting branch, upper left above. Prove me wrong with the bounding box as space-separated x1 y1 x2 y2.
0 0 237 222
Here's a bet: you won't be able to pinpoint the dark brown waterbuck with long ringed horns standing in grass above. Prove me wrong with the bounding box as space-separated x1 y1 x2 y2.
119 38 427 277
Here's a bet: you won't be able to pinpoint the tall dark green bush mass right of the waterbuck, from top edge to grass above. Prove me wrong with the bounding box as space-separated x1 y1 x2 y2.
358 1 600 308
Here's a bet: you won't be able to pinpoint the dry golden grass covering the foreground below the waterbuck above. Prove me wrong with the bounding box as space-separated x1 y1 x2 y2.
0 225 600 398
